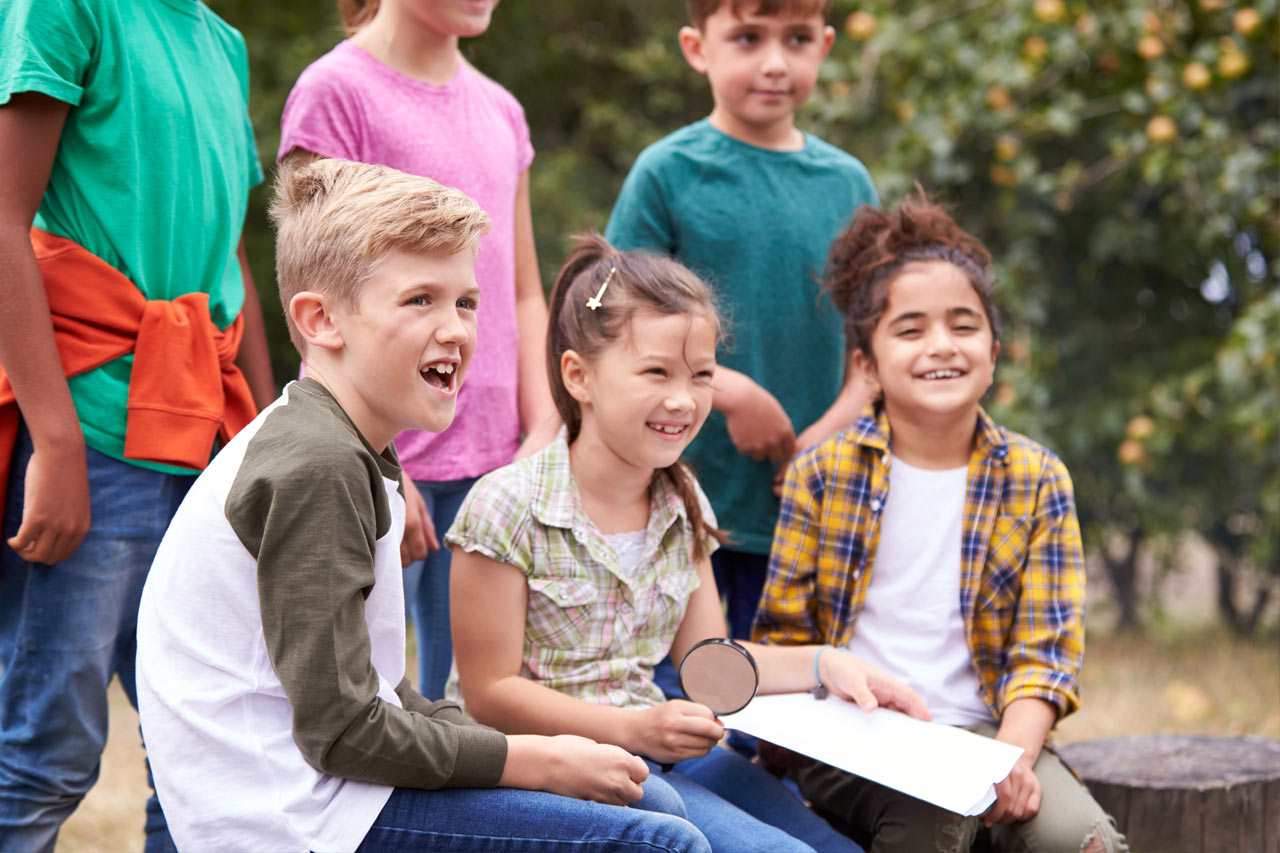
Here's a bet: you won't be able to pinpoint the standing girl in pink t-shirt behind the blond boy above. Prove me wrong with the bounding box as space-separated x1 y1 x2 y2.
279 0 559 699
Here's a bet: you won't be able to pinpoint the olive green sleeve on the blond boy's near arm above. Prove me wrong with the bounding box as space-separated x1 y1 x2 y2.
225 389 507 789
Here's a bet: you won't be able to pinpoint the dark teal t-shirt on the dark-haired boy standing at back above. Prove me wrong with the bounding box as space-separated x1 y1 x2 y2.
605 119 878 553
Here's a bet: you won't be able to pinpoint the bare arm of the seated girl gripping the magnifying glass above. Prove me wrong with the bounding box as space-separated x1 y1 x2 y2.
449 548 723 761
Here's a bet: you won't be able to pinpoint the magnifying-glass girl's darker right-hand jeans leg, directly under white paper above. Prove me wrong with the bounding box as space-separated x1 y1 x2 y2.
676 749 863 853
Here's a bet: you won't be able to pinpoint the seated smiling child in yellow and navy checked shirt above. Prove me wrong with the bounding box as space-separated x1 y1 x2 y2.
753 199 1125 853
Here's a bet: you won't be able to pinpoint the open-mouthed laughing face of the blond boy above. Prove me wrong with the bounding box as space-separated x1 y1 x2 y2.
317 250 480 450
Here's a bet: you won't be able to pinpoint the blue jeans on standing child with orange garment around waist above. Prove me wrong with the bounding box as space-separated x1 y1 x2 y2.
0 428 193 850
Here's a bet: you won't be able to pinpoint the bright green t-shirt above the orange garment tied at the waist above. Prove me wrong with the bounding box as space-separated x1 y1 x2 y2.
0 0 262 473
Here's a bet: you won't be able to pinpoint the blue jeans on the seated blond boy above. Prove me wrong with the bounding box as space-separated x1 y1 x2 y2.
357 788 710 853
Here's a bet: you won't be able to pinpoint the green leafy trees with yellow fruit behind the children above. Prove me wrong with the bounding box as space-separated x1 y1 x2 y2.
210 0 1280 631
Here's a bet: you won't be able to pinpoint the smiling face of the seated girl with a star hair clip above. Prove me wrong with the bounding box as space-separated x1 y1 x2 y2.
561 311 716 473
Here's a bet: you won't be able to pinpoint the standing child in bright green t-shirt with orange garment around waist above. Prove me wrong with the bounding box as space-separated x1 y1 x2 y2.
0 0 274 850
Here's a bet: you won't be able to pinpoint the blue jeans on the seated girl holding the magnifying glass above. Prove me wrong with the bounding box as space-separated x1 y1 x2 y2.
641 747 861 853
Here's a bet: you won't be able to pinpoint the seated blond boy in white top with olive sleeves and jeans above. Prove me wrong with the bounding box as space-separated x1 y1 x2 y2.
138 160 705 850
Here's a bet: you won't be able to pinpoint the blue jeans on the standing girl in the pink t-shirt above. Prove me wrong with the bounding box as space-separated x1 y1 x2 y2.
404 476 479 699
